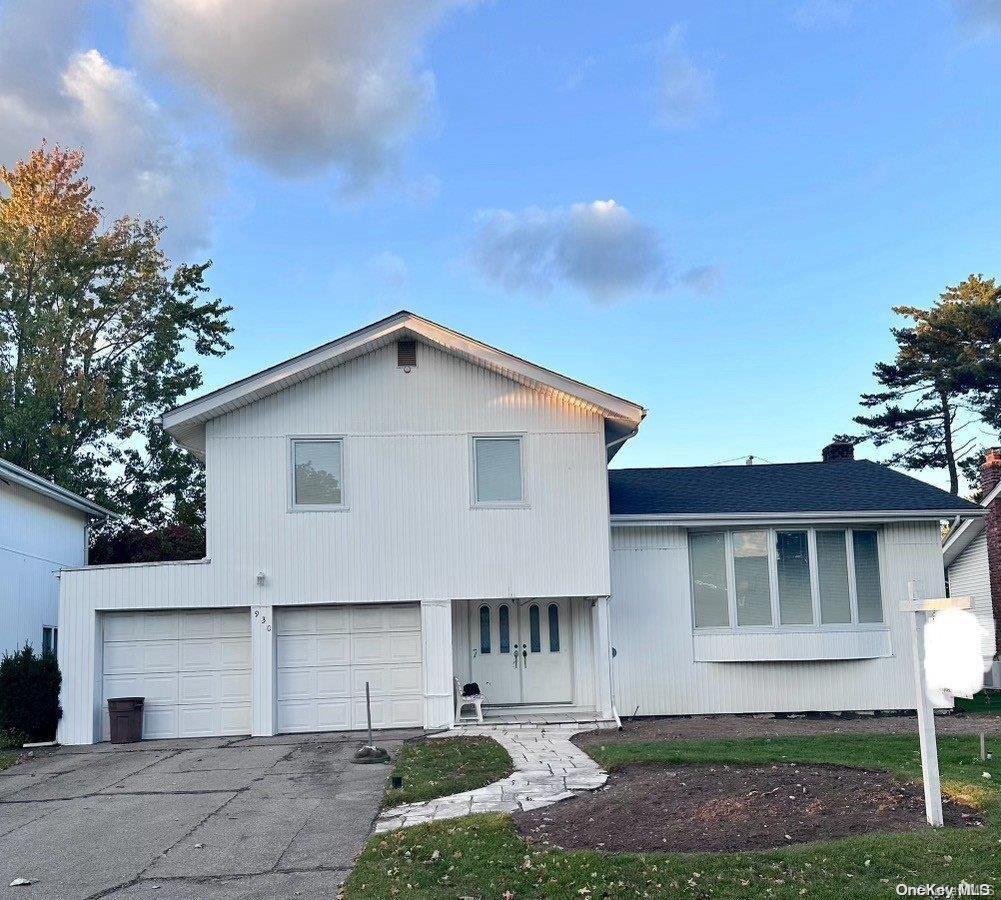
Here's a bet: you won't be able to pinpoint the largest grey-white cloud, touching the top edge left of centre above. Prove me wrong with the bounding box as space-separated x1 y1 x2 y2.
138 0 470 194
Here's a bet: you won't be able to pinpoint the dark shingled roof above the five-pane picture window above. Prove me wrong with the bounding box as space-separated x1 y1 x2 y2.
609 460 981 516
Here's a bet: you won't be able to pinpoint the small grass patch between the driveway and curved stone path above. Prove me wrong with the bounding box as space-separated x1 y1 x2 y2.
385 738 514 806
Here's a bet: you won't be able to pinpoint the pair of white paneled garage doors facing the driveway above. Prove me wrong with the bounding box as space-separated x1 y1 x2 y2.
101 604 423 740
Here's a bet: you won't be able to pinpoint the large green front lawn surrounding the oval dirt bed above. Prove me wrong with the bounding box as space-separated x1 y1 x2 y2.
344 736 1001 900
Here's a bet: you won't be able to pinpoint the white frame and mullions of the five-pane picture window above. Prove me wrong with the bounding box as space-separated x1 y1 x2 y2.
689 525 889 635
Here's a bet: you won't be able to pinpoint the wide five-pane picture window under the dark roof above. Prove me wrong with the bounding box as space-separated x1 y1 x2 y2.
689 528 883 630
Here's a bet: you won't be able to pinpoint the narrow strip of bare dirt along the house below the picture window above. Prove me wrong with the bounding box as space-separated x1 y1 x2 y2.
573 714 1001 747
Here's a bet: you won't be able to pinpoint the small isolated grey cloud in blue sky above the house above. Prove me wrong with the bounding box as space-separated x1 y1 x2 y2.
473 200 669 303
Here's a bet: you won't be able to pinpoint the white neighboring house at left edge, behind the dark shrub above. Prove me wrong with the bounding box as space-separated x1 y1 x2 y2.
0 460 110 656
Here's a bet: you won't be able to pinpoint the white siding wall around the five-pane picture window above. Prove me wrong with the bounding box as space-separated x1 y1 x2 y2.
610 523 945 716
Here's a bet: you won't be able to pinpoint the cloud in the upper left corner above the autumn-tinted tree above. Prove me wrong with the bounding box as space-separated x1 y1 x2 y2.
0 0 214 255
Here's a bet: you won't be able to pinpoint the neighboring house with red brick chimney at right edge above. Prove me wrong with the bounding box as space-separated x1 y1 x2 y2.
942 449 1001 688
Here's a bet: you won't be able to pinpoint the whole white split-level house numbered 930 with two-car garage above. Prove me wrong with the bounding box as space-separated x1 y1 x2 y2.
50 312 984 744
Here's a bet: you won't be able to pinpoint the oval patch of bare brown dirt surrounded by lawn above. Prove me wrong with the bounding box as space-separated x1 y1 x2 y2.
514 764 981 853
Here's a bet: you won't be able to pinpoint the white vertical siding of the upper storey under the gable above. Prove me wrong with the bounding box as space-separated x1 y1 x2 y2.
206 343 610 604
